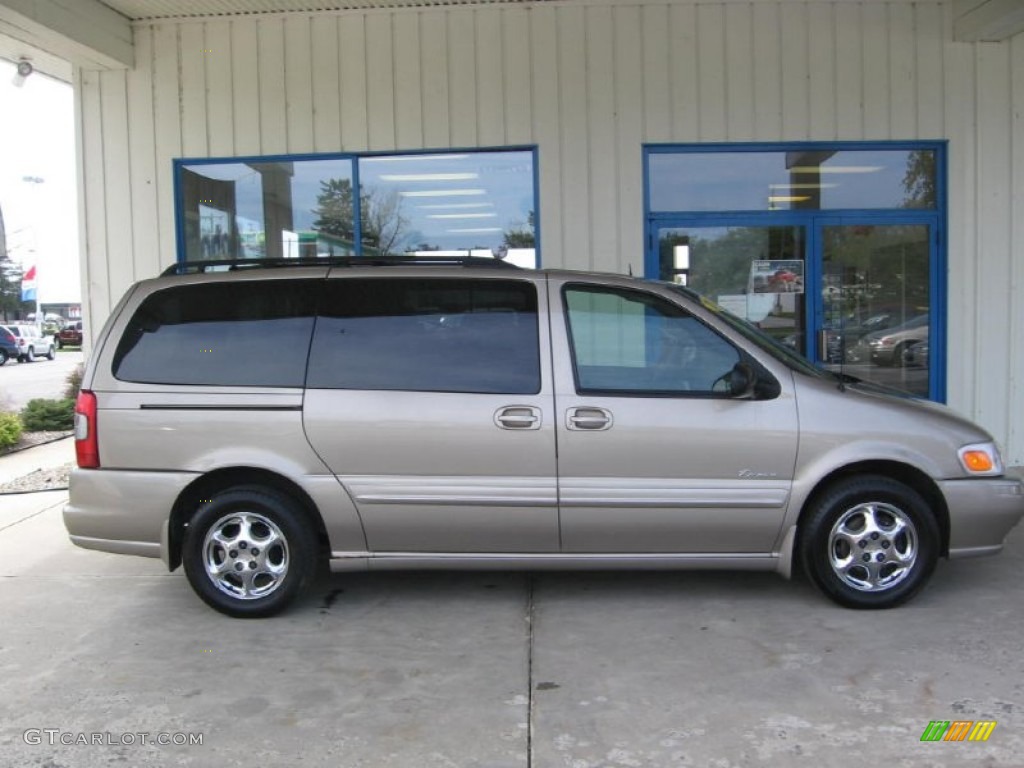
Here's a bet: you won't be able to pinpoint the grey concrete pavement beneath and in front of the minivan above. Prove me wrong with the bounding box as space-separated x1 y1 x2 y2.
0 493 1024 768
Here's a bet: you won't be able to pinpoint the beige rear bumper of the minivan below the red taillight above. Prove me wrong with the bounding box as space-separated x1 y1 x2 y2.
63 469 197 563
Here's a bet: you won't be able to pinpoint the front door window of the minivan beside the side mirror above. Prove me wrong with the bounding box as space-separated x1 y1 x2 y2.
565 286 739 396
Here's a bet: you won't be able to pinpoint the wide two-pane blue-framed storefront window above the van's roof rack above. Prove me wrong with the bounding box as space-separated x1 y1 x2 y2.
179 151 537 267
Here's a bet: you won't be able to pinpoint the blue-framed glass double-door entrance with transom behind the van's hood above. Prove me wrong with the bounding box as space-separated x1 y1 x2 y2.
644 141 946 400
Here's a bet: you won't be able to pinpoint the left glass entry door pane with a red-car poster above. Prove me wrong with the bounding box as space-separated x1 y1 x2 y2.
647 222 808 354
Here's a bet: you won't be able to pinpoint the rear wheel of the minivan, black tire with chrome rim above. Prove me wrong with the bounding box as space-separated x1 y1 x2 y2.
181 486 316 618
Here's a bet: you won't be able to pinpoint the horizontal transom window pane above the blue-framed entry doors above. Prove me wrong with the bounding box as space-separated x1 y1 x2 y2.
648 148 938 212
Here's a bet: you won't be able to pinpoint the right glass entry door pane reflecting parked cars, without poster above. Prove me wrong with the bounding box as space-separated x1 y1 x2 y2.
812 222 937 397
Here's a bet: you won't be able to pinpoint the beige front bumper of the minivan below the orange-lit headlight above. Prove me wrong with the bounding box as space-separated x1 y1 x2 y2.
939 477 1024 557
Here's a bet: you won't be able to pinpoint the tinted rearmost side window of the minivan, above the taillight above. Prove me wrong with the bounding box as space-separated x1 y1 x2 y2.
114 280 318 387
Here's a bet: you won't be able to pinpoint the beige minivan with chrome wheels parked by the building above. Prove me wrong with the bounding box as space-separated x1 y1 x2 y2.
65 258 1024 616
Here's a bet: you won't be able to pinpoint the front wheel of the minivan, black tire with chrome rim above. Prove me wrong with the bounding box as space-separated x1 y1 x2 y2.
800 475 939 608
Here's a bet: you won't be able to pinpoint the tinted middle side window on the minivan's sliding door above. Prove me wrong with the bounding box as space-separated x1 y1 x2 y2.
307 279 541 394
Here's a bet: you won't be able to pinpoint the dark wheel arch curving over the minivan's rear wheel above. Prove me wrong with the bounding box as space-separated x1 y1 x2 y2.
167 467 330 570
